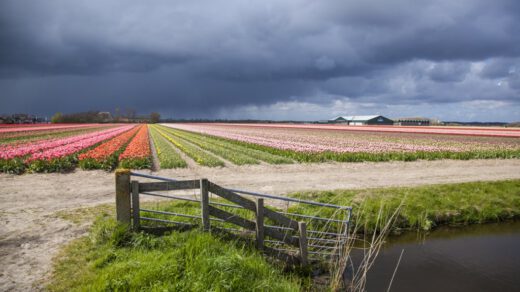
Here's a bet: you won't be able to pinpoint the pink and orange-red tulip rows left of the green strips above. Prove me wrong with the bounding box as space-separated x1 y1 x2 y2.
0 124 151 173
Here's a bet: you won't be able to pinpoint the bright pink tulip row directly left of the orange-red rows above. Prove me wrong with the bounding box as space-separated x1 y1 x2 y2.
26 125 135 163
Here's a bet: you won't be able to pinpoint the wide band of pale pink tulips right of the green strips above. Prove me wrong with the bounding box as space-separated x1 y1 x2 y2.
167 124 520 153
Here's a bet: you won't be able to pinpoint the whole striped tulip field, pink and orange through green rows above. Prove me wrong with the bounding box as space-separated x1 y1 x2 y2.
0 123 520 173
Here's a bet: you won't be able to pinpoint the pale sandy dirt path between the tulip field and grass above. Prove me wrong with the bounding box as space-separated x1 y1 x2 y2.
0 160 520 291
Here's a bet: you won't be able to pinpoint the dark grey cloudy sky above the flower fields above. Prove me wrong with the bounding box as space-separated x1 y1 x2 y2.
0 0 520 122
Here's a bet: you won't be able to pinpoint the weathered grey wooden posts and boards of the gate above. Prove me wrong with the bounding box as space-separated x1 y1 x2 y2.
116 171 350 266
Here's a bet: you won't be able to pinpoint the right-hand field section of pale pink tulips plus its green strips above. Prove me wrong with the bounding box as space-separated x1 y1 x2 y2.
162 123 520 164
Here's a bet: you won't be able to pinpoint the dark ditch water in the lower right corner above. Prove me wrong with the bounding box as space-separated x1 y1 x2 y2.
367 221 520 292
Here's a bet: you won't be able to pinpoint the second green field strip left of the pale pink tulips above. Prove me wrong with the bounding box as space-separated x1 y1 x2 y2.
154 129 260 165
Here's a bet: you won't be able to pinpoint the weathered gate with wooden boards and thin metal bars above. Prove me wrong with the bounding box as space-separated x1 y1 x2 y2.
116 170 351 265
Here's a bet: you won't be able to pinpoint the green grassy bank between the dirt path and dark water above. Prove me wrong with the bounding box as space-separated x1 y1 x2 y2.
291 180 520 233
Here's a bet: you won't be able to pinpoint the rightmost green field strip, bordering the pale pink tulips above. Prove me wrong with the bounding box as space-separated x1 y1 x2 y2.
158 127 293 164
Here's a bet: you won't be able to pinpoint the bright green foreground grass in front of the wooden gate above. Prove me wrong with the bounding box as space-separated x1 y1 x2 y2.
47 216 302 291
